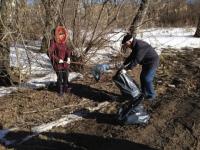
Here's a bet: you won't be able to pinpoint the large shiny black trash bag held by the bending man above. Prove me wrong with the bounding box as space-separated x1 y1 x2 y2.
113 70 150 124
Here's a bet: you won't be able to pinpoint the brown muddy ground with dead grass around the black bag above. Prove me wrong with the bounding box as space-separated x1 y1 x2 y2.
0 49 200 150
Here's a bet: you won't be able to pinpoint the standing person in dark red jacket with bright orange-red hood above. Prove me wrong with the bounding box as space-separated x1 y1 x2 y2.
48 26 71 96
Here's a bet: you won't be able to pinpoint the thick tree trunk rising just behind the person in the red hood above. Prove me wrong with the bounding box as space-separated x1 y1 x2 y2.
40 0 63 52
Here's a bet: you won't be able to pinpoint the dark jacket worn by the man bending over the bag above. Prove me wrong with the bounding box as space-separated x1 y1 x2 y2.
124 39 159 69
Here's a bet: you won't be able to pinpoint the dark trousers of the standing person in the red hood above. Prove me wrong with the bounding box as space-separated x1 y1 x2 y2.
56 70 69 95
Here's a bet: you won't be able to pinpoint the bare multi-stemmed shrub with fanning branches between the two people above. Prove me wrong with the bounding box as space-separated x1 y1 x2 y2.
58 0 125 69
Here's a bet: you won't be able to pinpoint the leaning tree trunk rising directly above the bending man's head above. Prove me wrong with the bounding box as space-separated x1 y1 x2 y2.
129 0 150 37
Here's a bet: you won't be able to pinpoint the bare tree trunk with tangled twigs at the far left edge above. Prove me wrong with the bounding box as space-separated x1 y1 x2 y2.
0 0 29 85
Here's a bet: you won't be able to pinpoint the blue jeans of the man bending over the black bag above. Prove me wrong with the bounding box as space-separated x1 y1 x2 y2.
140 66 157 99
